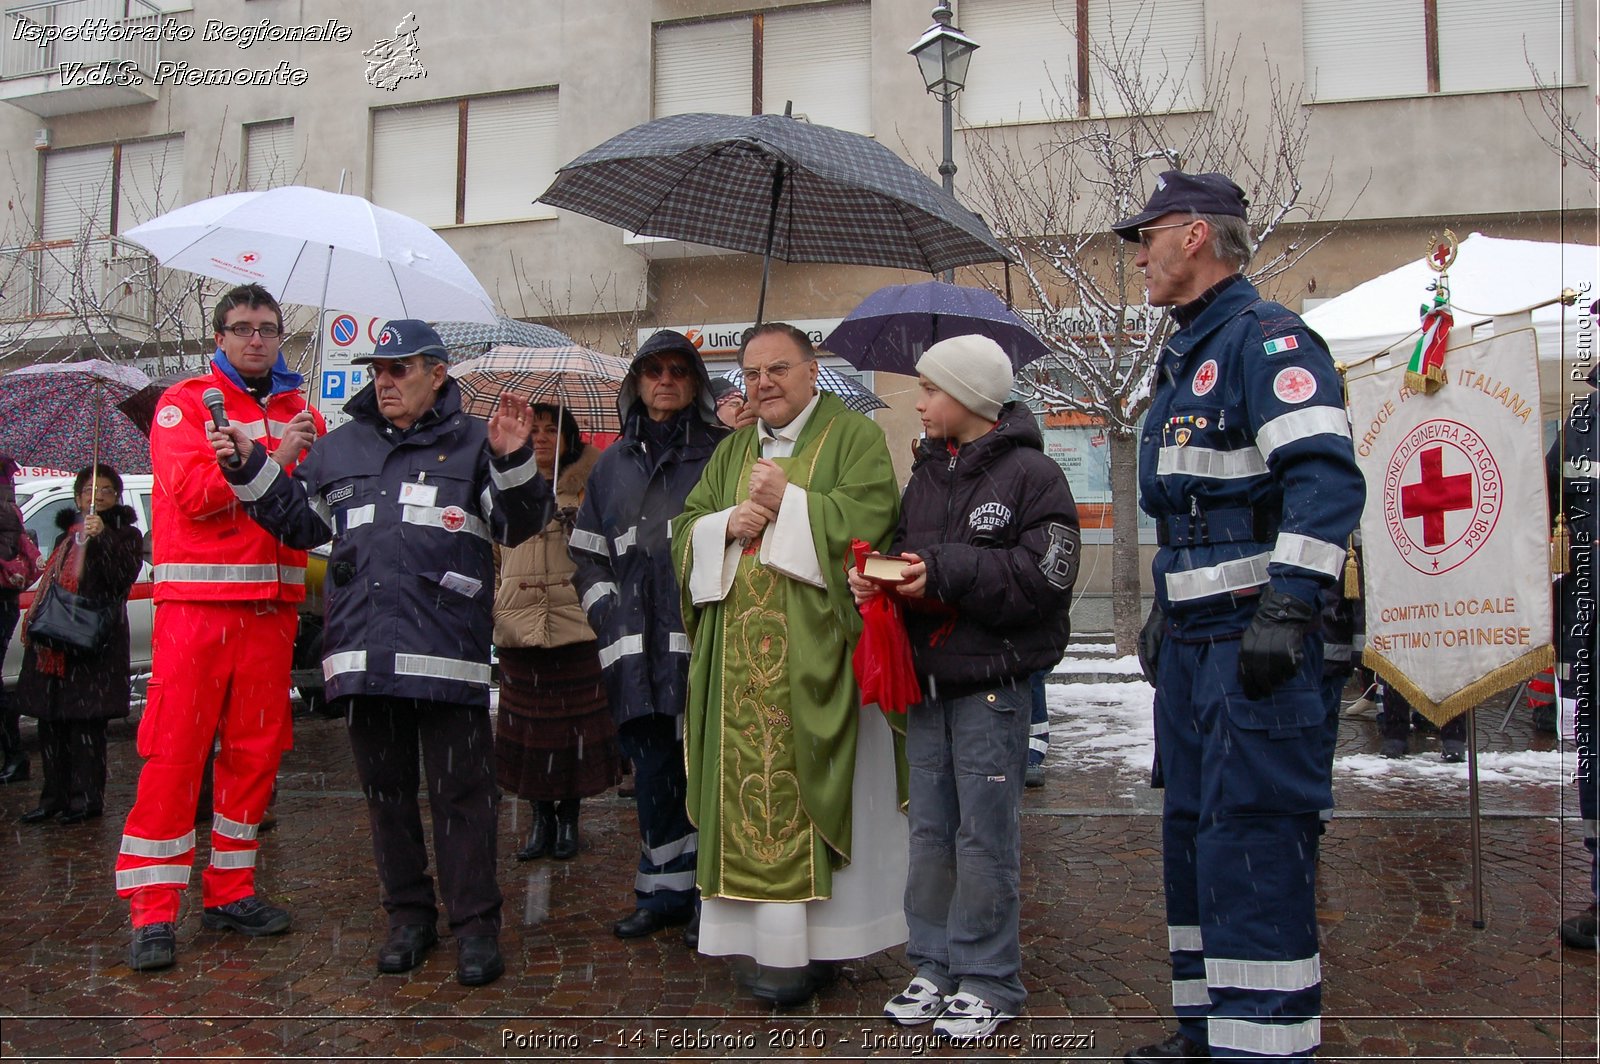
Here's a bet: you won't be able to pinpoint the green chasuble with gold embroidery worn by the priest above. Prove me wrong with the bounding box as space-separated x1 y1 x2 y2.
672 392 904 901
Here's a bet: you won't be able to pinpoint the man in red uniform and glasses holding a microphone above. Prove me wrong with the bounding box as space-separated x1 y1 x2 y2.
117 285 325 971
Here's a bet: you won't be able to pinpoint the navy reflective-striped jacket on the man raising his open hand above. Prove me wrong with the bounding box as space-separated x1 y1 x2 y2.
227 379 554 706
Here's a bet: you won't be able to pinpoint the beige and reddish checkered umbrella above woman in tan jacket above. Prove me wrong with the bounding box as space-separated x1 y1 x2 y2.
450 347 630 432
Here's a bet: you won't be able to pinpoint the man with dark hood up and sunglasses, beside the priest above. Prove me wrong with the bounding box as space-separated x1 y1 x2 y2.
571 330 728 942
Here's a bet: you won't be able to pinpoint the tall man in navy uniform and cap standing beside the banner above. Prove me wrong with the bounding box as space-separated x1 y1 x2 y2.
1112 170 1365 1062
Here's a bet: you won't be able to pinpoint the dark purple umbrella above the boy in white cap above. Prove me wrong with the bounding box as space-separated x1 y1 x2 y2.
821 280 1050 373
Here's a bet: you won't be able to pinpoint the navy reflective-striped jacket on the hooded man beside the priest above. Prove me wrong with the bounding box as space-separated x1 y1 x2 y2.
568 403 726 723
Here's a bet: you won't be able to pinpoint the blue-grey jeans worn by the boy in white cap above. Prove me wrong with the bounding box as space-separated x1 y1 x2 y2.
906 680 1029 1014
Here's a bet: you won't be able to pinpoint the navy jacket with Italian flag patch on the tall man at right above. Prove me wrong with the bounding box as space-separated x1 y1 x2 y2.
1139 277 1366 635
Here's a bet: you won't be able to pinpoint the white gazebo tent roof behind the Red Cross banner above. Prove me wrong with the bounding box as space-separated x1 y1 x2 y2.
1306 234 1600 421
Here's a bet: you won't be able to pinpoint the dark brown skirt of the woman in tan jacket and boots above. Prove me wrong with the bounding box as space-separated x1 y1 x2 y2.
494 642 622 802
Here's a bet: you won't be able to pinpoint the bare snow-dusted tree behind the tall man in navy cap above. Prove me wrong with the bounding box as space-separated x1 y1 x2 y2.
966 27 1331 653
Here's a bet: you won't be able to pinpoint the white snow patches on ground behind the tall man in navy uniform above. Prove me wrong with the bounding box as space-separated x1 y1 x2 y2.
1045 668 1578 787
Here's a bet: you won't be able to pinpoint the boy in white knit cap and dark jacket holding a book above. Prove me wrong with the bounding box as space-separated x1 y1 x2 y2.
850 336 1078 1040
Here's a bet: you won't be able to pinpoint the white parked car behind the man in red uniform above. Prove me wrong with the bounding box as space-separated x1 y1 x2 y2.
5 474 328 712
